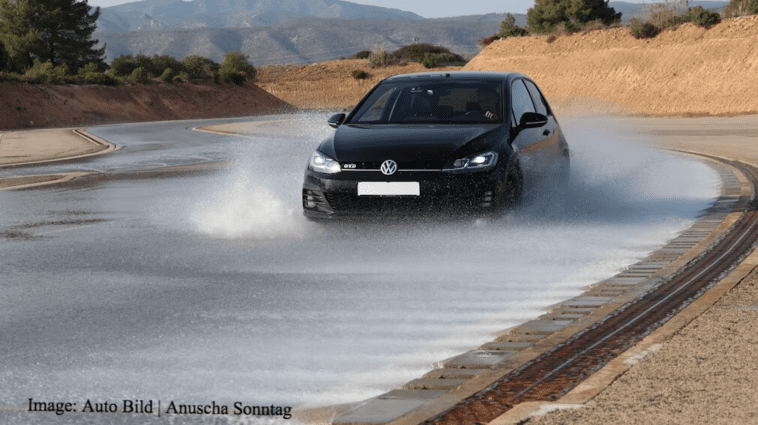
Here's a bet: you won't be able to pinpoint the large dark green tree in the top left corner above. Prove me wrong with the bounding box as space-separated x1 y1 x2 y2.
0 0 105 72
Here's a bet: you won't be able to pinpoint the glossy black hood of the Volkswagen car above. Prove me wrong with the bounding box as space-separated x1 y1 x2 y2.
322 124 498 163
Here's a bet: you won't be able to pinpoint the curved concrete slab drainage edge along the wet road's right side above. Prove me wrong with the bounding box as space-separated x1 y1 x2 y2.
332 153 758 424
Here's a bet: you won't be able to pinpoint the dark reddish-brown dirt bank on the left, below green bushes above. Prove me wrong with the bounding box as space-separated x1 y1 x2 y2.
0 83 291 130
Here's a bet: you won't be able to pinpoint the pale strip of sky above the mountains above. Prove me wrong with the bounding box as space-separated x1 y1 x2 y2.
88 0 654 18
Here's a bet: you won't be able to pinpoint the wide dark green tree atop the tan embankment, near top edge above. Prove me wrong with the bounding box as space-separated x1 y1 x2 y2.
526 0 621 33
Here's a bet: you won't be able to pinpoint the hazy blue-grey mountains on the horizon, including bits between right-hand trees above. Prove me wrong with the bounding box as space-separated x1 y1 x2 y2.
94 0 726 65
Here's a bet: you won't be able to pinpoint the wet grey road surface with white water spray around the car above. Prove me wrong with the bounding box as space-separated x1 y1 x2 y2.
0 114 718 423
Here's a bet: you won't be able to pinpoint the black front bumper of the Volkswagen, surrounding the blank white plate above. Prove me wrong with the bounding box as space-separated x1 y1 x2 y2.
302 169 503 219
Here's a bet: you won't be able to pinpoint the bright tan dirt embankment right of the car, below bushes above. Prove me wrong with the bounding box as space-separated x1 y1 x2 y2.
465 16 758 116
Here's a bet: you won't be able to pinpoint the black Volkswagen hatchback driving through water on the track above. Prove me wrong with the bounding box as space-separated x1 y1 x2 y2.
303 72 569 219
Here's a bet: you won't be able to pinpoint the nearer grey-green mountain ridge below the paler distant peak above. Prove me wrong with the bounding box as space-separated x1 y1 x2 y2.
95 14 504 65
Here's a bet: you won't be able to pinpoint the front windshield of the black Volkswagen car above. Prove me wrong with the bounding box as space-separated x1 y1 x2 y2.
349 81 503 124
